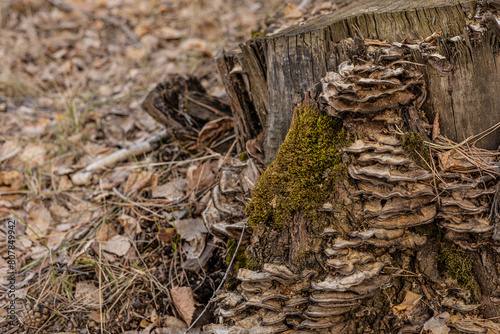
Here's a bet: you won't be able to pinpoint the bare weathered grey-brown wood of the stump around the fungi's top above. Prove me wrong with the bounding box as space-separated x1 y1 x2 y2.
220 0 500 163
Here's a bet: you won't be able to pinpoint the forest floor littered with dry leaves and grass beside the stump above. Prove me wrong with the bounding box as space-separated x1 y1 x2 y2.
0 0 352 333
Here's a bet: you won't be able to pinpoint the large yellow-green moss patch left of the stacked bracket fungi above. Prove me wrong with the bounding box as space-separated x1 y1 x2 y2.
246 106 348 231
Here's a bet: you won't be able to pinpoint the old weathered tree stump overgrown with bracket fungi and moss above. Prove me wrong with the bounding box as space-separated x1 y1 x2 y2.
205 0 500 333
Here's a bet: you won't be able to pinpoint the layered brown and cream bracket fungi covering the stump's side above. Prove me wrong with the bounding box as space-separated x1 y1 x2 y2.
204 40 498 333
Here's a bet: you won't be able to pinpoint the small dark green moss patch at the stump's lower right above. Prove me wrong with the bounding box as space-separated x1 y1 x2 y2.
438 242 478 296
